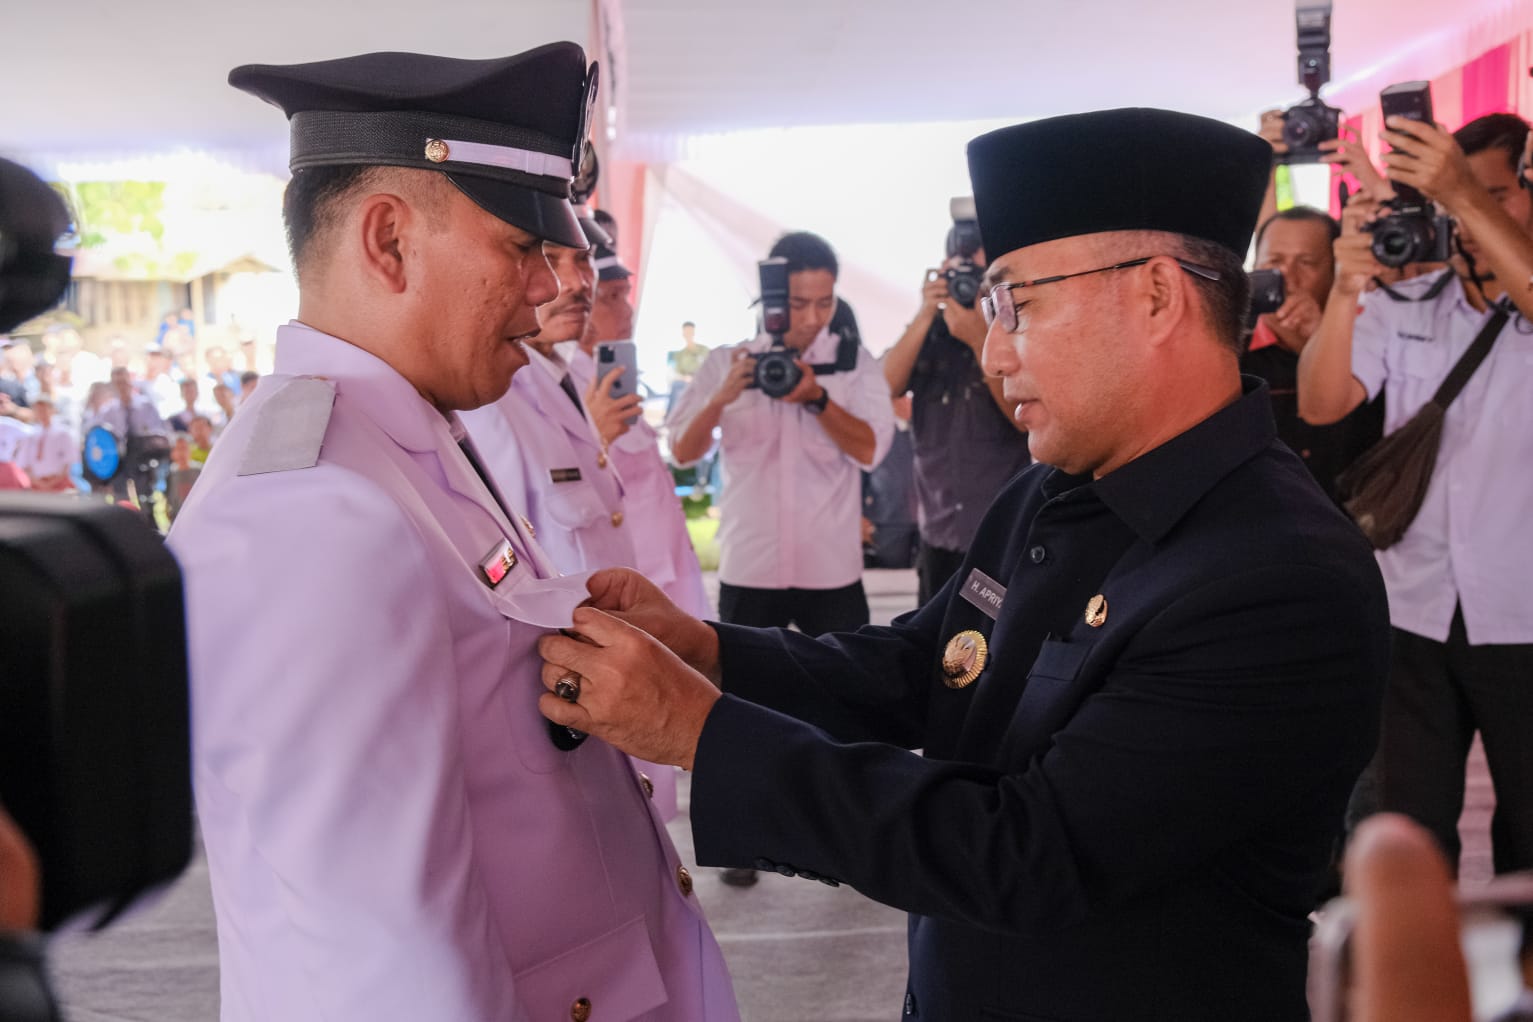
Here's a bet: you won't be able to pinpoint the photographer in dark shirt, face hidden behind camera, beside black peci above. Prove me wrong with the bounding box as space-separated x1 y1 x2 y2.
883 199 1032 604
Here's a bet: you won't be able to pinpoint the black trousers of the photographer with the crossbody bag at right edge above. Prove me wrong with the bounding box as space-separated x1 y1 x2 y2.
1372 611 1533 873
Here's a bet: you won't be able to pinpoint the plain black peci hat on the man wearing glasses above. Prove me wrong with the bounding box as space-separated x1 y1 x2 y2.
969 107 1272 262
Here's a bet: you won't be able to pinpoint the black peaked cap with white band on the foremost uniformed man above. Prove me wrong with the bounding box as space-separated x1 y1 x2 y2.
228 43 596 247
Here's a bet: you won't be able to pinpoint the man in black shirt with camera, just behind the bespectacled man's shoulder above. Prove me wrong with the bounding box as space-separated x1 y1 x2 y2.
1240 205 1384 500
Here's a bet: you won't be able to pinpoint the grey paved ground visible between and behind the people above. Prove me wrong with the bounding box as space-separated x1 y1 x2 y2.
52 572 1495 1022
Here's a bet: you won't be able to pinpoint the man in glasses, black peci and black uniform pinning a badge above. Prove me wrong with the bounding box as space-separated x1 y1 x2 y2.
540 110 1389 1022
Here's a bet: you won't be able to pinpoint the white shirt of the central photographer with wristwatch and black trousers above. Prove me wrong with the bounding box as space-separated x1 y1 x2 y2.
665 328 894 588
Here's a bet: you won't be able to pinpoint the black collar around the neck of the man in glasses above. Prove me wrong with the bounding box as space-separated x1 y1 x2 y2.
1042 375 1277 542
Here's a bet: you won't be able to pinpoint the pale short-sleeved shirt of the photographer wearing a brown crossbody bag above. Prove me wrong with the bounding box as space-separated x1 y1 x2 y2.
1352 270 1533 645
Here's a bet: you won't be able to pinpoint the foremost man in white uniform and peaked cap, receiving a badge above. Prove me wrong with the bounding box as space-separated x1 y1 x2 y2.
170 43 737 1022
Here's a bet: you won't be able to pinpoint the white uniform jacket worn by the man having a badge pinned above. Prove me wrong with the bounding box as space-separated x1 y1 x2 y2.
170 325 737 1022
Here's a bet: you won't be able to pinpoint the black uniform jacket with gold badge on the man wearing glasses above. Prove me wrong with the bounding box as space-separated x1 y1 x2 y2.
691 378 1389 1022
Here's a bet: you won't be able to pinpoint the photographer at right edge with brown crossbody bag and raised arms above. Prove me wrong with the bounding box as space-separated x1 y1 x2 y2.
1298 113 1533 872
